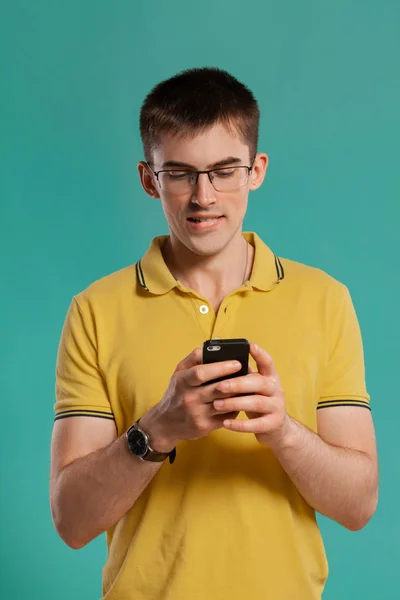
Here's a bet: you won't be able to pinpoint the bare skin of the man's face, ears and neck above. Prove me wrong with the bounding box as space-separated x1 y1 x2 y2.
138 124 268 312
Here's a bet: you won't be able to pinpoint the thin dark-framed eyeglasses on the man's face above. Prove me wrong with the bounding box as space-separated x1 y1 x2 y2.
147 163 253 194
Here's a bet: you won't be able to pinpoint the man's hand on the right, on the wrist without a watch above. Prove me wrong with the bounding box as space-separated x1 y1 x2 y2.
214 343 291 447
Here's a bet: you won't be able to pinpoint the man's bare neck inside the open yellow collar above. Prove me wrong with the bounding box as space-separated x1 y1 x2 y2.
162 232 254 300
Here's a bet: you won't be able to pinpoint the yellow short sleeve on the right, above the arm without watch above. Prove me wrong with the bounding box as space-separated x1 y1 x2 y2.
317 284 370 408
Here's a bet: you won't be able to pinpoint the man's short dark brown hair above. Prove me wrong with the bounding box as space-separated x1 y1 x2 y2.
140 67 260 163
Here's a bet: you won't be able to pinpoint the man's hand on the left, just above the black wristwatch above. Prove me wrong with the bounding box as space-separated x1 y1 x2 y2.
140 348 242 452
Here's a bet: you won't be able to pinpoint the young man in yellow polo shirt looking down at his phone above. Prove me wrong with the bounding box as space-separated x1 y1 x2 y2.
51 69 378 600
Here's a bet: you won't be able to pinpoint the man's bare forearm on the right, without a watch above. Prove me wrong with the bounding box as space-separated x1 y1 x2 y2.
273 419 378 530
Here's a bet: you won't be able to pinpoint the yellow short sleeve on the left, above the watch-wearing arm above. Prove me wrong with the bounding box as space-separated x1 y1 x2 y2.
54 298 114 420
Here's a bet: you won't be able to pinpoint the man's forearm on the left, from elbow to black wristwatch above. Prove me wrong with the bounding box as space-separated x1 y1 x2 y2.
51 435 163 548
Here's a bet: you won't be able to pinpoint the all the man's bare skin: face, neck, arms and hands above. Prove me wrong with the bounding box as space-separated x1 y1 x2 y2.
50 124 378 548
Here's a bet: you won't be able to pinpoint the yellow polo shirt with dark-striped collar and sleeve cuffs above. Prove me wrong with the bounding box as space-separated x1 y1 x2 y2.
55 233 369 600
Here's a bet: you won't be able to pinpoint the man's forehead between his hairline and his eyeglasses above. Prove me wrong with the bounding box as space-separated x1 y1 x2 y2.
153 123 250 170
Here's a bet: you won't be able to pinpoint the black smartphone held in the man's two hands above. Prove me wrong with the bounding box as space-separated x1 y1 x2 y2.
203 338 250 385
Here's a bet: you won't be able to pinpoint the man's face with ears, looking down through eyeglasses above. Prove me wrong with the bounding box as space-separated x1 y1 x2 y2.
138 124 268 255
